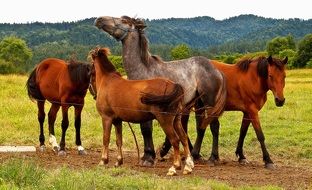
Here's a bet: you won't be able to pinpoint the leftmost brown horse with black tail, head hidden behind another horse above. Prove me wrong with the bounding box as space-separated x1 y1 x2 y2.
26 58 92 155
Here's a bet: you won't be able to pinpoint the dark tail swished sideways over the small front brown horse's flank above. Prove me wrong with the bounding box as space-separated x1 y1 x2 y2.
141 84 184 107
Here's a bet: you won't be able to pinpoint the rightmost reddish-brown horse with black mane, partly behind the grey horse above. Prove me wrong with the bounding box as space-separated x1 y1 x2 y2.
192 56 288 168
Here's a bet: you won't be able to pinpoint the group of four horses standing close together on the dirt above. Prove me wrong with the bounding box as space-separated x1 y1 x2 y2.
27 16 287 175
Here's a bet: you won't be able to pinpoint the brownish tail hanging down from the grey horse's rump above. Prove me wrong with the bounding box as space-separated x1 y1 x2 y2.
201 72 227 128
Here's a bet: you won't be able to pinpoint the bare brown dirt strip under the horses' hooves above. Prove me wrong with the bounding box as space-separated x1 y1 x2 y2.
0 150 312 189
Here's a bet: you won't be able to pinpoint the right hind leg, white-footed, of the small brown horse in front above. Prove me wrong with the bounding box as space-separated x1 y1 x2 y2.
173 116 194 174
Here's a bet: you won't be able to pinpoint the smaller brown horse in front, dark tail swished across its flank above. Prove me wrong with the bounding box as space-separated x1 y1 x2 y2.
90 48 194 175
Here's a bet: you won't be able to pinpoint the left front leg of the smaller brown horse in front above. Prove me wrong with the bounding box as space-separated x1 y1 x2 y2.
99 118 112 165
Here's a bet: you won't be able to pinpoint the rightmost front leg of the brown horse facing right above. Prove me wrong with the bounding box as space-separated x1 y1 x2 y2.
250 112 274 169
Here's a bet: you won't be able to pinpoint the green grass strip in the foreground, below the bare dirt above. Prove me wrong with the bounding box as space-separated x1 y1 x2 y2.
0 159 280 190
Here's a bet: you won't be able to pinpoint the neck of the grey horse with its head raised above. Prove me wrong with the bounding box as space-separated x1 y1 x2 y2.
122 32 151 79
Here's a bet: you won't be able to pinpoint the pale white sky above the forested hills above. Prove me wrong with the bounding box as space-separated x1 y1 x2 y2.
0 0 312 23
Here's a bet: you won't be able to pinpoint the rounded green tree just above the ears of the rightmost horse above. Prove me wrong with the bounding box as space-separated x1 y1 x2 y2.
266 35 296 55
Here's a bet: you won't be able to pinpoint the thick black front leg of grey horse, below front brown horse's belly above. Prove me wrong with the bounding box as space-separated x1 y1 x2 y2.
140 120 156 167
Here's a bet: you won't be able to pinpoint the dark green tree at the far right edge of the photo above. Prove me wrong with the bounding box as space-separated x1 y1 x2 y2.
294 33 312 67
